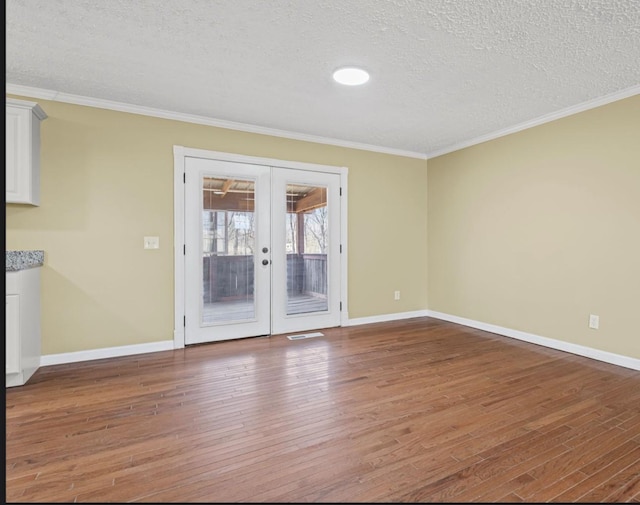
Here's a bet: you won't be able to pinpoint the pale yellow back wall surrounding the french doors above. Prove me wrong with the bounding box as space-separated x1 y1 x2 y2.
6 96 427 355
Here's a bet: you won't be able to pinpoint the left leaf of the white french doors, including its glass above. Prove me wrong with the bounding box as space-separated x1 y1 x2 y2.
184 157 271 344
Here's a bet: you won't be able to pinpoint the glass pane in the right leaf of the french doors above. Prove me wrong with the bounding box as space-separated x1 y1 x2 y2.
285 184 329 315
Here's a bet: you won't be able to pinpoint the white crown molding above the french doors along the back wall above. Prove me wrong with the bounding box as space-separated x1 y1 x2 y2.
5 83 427 160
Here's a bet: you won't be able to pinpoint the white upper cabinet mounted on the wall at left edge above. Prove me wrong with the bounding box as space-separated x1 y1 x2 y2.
5 98 47 205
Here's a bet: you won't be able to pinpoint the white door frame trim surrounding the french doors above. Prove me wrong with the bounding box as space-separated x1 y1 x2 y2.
173 145 349 349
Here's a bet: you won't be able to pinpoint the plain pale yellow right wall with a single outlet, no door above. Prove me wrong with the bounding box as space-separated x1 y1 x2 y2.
428 96 640 358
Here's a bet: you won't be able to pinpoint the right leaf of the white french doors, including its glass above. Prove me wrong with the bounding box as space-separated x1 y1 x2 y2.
271 167 342 333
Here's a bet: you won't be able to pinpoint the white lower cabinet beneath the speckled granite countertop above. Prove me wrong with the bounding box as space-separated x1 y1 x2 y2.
5 267 41 387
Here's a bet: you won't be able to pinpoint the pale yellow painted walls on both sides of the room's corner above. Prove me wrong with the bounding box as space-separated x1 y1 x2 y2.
6 89 640 358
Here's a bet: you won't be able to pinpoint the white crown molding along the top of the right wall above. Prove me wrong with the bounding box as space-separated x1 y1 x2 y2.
427 84 640 159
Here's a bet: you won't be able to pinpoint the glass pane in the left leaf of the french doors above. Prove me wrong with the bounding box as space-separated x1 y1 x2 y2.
201 176 256 325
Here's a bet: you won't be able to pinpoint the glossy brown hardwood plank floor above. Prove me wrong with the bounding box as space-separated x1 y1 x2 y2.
6 317 640 503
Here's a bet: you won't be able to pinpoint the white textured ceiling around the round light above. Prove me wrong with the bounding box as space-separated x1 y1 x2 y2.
6 0 640 156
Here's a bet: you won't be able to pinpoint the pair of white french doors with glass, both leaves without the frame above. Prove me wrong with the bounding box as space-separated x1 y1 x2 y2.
184 157 341 344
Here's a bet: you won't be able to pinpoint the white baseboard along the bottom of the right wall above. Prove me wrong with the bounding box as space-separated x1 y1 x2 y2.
426 310 640 370
